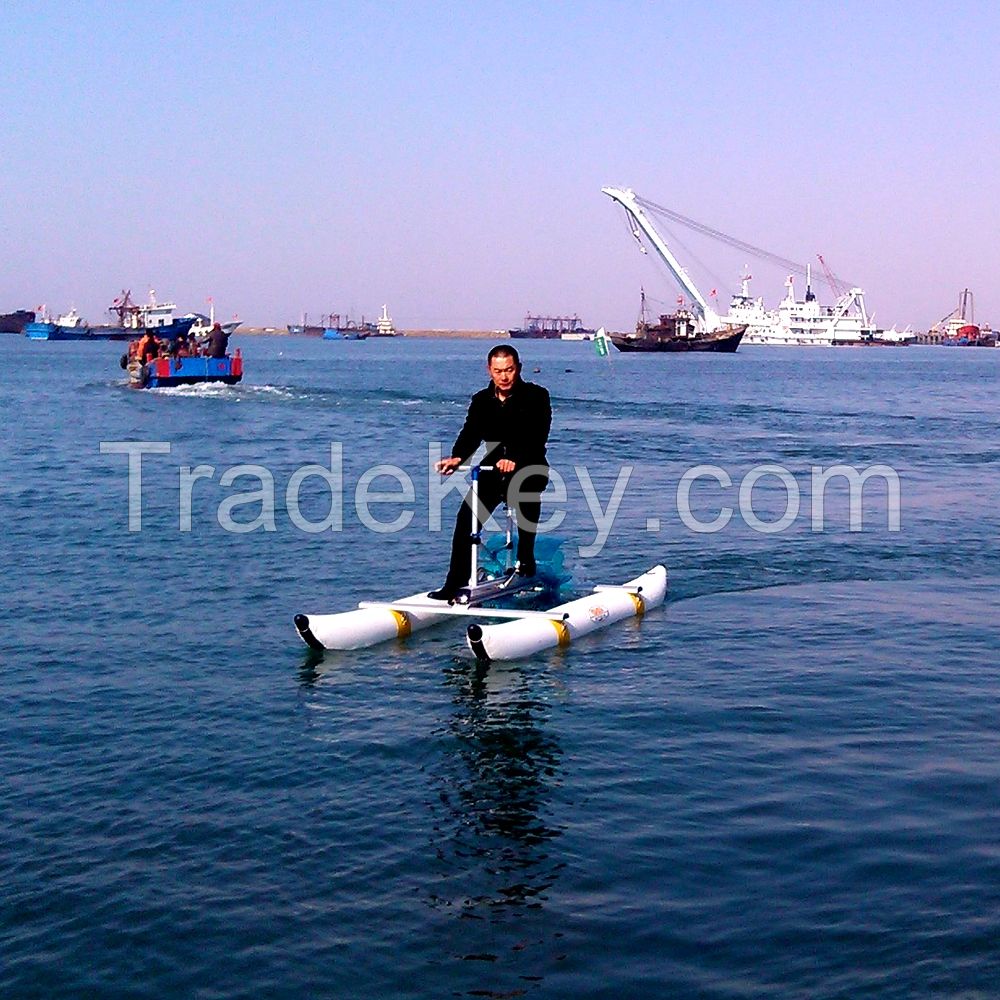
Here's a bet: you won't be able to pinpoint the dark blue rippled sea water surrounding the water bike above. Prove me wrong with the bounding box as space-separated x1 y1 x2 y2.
0 336 1000 1000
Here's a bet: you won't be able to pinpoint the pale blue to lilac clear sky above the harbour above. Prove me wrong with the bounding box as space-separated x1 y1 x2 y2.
0 0 1000 329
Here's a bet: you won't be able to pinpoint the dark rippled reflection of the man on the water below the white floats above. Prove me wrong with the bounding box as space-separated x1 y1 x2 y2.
428 661 565 997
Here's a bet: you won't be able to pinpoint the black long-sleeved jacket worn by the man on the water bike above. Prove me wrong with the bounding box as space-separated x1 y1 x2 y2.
451 379 552 492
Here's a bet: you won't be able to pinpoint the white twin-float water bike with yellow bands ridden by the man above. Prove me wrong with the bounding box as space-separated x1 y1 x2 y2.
294 466 667 662
